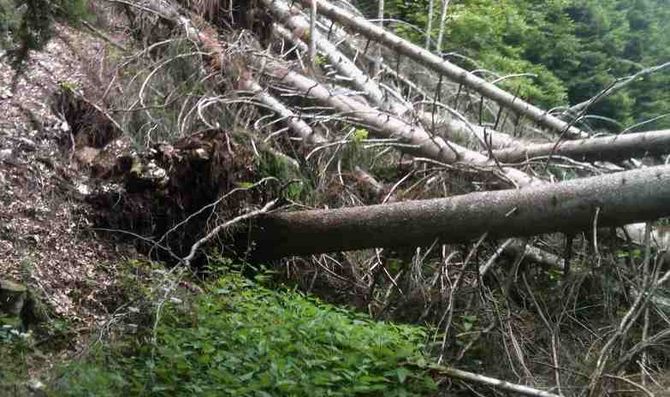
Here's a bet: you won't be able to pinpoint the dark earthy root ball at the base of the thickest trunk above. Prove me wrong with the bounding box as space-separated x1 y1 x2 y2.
90 130 266 260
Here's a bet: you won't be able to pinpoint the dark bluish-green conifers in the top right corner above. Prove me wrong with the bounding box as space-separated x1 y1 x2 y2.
566 0 670 128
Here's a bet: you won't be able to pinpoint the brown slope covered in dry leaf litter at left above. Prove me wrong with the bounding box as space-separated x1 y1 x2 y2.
0 20 139 378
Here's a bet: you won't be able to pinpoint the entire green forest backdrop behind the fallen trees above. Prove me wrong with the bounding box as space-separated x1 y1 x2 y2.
359 0 670 131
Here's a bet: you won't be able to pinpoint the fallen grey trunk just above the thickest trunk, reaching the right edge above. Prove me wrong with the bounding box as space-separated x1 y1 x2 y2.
493 130 670 163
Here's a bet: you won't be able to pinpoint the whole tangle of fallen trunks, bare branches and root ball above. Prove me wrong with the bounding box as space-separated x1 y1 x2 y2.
19 0 670 396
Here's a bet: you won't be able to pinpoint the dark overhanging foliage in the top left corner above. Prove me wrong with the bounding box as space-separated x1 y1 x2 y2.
0 0 88 68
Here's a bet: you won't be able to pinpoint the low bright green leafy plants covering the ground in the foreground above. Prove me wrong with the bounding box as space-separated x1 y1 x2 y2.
54 275 435 396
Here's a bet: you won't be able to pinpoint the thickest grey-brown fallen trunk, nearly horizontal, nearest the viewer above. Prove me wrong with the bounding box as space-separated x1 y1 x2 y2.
254 166 670 258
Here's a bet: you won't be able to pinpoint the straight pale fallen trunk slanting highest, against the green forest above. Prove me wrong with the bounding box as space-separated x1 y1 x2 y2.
302 0 588 138
